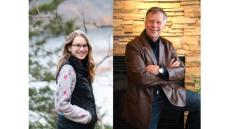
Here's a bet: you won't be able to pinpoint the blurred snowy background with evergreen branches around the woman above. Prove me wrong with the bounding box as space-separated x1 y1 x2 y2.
29 0 113 129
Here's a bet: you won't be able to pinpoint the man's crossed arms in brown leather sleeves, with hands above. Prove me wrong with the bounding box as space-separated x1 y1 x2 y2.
125 44 184 87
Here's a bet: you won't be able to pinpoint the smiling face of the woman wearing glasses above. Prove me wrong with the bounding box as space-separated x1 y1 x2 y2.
68 36 89 60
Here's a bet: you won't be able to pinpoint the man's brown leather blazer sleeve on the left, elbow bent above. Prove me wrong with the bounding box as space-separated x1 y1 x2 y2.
125 43 167 87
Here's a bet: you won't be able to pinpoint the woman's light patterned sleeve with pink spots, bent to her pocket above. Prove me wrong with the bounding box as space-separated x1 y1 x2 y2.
55 65 91 124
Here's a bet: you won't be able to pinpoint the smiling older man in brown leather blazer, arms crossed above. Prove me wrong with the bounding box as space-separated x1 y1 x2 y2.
123 7 200 129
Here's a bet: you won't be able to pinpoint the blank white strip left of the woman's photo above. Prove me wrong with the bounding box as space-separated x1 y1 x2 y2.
0 0 29 129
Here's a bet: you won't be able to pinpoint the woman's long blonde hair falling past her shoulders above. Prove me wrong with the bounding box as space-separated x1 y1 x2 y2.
57 30 95 82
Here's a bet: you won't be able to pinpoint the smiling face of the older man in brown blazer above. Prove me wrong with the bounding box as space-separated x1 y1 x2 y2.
145 12 165 41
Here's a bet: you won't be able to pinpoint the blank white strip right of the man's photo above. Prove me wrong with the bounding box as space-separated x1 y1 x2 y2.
201 0 230 129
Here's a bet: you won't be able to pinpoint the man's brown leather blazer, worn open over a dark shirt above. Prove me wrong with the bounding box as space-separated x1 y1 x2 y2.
122 31 186 129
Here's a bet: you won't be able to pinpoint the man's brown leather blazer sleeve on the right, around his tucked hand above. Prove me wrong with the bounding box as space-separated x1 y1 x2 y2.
166 45 185 81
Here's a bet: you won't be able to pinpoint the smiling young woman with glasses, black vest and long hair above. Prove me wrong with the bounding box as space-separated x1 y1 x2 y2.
55 30 97 129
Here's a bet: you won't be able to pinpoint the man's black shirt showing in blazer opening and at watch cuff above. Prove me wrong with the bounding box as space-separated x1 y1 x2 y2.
145 32 169 79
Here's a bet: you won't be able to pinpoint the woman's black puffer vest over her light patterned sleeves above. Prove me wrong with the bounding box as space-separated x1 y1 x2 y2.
58 56 97 129
